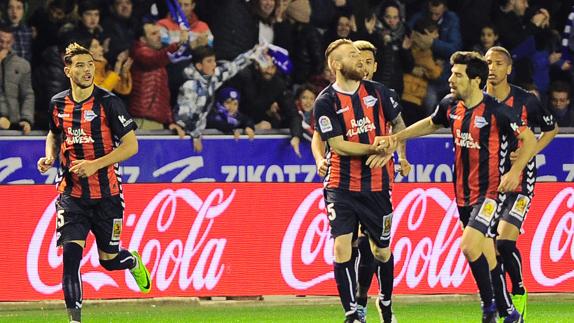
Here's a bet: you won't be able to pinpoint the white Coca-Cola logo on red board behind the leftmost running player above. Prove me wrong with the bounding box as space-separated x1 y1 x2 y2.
26 188 235 294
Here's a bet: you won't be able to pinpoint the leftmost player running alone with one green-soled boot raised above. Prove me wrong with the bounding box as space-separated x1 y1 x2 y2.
37 43 151 322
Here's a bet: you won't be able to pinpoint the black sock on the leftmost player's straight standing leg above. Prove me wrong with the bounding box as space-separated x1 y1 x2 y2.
62 242 84 322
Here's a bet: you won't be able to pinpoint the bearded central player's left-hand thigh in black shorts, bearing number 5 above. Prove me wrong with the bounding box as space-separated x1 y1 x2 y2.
324 190 358 238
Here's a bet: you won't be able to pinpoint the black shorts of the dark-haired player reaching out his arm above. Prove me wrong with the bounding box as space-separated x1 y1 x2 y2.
458 198 498 235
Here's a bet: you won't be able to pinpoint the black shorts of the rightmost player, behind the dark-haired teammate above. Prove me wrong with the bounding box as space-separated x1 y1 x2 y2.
489 192 532 238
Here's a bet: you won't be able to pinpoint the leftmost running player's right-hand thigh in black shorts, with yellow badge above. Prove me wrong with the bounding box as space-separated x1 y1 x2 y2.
92 195 124 255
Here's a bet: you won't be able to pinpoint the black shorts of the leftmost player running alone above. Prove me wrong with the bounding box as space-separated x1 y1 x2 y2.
56 194 124 253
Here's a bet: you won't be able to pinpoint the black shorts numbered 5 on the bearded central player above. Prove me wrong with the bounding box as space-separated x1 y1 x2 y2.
324 190 393 248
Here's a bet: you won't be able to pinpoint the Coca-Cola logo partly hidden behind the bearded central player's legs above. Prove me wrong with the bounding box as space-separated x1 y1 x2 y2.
281 188 469 290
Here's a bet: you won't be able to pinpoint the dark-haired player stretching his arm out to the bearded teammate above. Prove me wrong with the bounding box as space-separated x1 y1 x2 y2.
376 52 536 323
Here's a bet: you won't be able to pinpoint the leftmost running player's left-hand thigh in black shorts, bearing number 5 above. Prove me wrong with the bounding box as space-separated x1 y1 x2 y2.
56 194 91 246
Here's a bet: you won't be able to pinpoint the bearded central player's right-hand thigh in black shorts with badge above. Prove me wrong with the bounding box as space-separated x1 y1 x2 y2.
356 191 393 248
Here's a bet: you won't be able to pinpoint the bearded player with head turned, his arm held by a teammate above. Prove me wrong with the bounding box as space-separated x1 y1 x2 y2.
314 39 404 323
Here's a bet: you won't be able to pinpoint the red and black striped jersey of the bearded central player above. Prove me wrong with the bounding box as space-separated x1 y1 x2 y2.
314 80 401 192
